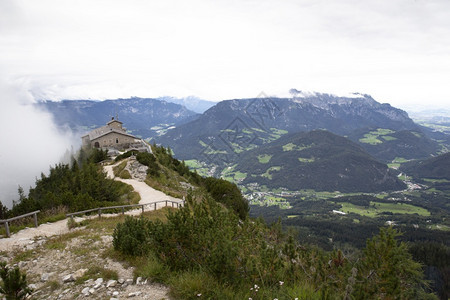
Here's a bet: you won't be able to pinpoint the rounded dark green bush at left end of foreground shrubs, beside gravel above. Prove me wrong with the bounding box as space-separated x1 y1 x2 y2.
113 216 149 256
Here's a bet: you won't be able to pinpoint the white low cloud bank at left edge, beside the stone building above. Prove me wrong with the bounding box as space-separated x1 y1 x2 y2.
0 78 77 207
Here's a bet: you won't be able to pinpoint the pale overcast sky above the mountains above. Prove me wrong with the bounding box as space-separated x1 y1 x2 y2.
0 0 450 108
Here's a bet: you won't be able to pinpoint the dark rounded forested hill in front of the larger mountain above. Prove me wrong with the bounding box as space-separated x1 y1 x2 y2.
233 130 406 192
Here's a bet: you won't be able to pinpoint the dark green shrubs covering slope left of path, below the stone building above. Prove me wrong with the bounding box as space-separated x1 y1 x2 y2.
2 149 139 220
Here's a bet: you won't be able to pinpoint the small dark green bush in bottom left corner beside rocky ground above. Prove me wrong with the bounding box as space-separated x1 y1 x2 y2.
0 262 31 300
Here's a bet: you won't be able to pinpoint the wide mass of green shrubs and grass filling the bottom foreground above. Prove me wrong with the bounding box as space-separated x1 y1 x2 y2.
113 197 435 299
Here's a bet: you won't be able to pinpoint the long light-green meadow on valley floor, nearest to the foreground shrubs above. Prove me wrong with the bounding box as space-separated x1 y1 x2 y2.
340 202 430 218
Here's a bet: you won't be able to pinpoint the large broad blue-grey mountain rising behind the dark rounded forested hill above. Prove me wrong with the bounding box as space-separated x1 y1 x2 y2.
156 94 442 164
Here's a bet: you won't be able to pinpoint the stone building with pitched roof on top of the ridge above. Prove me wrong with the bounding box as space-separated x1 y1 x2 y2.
81 117 151 152
